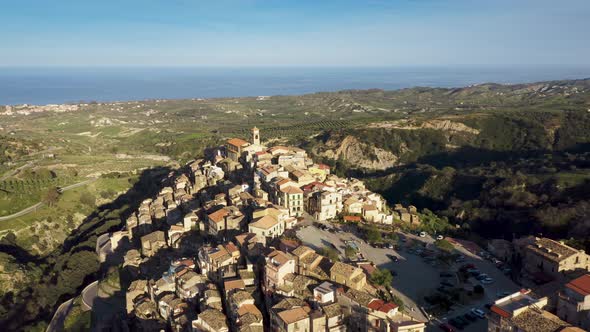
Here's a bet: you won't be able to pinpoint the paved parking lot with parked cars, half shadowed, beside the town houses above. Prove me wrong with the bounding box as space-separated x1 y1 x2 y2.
297 226 519 332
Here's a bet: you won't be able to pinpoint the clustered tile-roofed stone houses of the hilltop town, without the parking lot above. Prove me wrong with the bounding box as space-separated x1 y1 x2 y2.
91 128 590 332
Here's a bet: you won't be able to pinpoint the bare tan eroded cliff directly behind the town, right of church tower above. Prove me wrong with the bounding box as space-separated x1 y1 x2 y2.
314 135 399 170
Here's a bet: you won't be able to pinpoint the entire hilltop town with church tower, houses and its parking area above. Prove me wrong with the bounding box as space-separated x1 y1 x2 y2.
66 127 590 332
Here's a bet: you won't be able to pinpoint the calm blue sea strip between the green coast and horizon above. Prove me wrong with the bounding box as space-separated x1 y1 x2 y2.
0 66 590 105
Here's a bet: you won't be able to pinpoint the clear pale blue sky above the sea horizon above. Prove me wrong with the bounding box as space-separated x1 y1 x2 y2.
0 0 590 66
